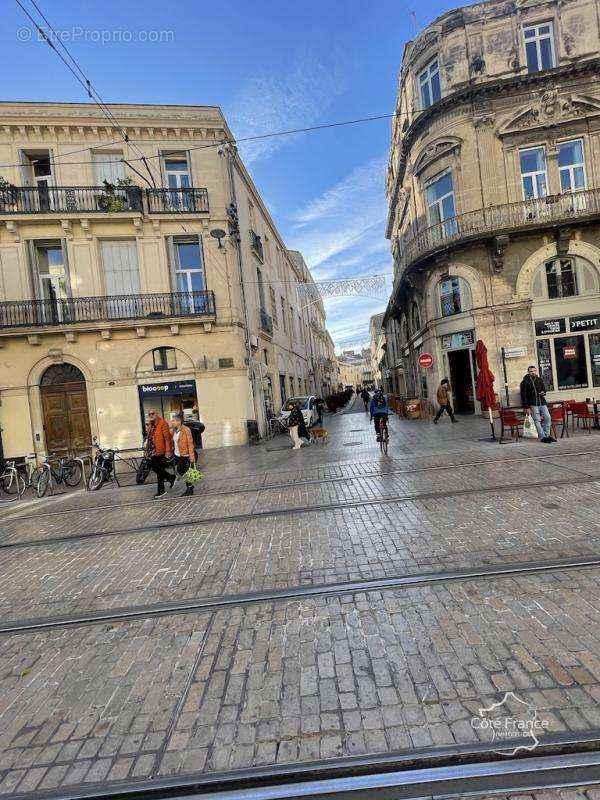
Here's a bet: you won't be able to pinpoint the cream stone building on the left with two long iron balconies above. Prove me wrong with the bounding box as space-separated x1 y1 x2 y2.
0 102 332 457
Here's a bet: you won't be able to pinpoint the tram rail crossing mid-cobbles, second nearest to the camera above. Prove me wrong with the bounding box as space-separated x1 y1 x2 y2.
0 553 600 635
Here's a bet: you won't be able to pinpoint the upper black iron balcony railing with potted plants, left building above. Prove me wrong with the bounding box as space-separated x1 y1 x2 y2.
0 186 209 214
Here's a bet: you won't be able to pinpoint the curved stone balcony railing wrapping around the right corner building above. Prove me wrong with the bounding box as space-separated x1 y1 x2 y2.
398 189 600 276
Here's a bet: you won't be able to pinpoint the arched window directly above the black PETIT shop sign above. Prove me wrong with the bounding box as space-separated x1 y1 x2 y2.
531 256 600 300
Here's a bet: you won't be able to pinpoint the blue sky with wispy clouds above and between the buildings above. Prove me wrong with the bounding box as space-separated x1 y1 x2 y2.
0 0 464 347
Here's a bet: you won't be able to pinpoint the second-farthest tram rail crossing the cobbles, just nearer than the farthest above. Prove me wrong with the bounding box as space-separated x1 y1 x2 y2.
0 475 600 550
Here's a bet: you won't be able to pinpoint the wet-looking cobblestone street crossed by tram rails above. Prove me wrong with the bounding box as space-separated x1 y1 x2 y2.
0 401 600 800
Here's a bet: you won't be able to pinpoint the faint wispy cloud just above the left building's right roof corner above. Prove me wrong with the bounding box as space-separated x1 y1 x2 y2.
229 55 343 166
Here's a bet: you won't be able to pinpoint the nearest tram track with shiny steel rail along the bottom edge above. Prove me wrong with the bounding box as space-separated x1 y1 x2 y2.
13 729 600 800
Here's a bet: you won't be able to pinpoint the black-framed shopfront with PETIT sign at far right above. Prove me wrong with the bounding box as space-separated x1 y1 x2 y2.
535 313 600 400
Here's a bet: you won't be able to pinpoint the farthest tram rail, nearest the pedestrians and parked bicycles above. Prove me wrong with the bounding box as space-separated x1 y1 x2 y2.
7 450 600 522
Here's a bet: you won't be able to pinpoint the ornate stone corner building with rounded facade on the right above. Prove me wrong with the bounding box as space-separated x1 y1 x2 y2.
384 0 600 412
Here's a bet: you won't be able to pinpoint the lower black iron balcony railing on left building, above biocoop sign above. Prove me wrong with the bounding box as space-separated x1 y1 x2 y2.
0 291 215 328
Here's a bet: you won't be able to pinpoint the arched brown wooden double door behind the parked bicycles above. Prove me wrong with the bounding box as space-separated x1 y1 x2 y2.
40 364 92 455
